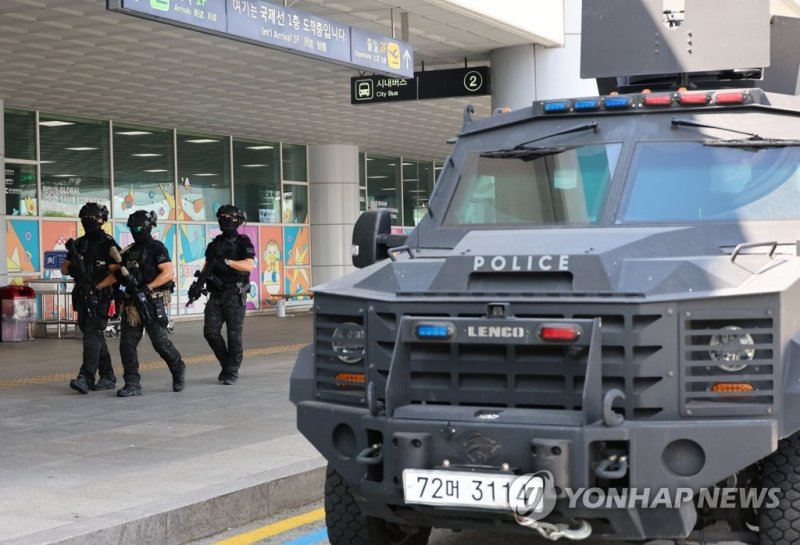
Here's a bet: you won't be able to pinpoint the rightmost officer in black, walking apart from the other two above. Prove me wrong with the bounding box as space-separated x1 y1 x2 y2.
203 204 256 384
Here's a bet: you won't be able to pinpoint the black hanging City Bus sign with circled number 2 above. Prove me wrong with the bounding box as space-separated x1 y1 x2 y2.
350 66 490 104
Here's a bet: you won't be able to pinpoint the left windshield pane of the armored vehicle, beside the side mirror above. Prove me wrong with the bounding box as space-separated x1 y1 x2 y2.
444 143 622 226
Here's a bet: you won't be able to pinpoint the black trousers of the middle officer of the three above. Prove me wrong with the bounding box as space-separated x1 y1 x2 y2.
119 312 186 386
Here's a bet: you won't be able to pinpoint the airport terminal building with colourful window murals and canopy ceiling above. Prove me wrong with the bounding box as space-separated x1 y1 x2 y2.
0 0 800 316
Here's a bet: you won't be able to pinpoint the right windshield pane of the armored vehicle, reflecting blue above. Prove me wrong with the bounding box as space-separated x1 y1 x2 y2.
618 142 800 223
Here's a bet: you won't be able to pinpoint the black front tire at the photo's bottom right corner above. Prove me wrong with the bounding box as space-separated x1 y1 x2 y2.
759 434 800 545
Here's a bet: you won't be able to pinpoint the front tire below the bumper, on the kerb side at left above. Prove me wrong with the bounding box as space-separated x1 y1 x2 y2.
325 465 431 545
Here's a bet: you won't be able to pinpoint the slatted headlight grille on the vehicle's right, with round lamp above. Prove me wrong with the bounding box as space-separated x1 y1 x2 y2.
681 309 777 416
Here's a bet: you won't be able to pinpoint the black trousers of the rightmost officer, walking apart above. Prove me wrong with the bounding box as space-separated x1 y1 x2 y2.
203 290 245 378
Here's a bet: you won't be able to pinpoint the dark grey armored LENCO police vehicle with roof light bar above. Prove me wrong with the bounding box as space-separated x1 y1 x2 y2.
291 0 800 545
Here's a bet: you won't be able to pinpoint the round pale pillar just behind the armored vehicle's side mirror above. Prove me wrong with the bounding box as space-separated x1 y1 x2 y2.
308 144 359 285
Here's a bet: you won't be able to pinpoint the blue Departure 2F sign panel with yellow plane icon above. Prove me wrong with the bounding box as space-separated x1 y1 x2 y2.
350 27 414 78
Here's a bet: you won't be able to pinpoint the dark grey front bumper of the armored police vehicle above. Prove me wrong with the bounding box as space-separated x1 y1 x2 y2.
297 401 778 539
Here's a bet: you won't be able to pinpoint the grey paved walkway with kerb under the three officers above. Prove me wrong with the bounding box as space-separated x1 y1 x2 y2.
0 311 323 545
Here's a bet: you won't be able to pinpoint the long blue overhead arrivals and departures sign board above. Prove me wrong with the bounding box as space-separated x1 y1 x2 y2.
106 0 414 77
